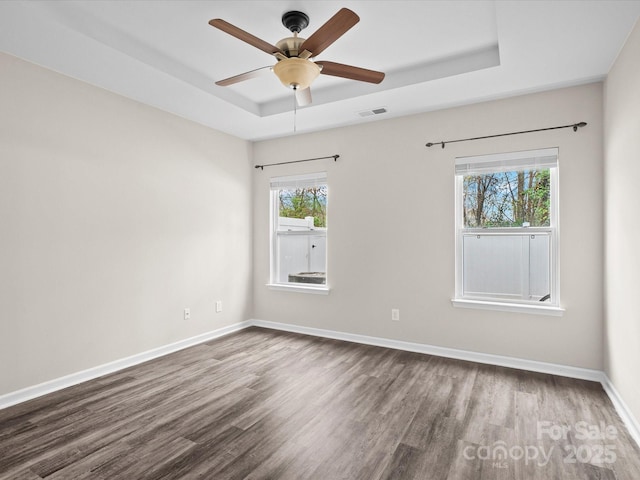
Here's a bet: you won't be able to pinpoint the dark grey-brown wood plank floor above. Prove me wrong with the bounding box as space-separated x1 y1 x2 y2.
0 328 640 480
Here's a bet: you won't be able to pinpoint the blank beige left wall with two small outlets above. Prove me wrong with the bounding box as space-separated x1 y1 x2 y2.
0 54 253 394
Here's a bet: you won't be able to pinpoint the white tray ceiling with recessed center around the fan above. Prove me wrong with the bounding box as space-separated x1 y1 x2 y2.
0 0 640 140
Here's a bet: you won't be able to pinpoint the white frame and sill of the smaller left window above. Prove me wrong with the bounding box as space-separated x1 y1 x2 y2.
267 172 330 295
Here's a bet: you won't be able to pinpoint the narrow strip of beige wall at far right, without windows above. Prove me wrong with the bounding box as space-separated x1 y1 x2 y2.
604 19 640 419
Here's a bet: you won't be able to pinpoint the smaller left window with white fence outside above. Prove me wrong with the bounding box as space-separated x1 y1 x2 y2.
271 173 328 290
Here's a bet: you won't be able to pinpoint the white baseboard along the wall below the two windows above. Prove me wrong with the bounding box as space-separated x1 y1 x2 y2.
251 320 604 382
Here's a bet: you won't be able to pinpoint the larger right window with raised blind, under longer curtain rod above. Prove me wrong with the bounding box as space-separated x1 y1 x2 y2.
454 148 559 309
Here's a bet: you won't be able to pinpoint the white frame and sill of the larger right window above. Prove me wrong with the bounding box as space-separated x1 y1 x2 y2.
452 148 564 316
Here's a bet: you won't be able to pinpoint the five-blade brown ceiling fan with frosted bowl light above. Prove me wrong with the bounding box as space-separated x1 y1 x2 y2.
209 8 384 106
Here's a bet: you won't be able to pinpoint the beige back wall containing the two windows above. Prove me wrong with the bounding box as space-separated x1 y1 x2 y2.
254 83 603 369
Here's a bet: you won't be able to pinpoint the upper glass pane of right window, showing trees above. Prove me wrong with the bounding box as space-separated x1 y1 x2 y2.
462 168 551 228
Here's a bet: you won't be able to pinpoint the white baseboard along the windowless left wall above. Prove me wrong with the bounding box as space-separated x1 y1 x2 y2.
0 320 252 410
